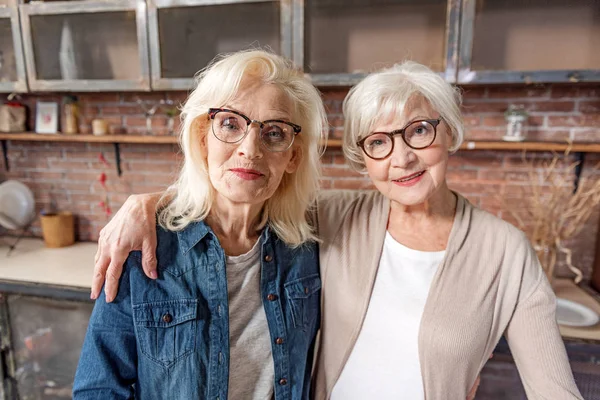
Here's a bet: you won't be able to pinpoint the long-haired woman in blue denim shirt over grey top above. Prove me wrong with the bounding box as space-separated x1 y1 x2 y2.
73 51 326 400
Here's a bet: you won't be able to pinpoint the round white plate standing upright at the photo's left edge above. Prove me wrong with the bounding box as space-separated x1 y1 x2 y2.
0 180 35 229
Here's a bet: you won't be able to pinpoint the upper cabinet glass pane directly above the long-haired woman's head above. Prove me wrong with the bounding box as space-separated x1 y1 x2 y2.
158 2 280 78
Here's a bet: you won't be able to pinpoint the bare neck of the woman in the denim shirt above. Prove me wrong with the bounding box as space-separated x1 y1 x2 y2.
206 198 264 256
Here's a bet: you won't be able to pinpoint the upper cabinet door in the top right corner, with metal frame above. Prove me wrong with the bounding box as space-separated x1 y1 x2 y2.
459 0 600 83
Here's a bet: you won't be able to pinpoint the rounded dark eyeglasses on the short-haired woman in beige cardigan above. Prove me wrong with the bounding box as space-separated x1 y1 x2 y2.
356 119 441 160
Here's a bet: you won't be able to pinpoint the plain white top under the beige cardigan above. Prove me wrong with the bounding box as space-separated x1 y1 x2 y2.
331 232 445 400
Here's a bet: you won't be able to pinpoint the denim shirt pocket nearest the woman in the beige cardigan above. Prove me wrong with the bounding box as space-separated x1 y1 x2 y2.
284 274 321 329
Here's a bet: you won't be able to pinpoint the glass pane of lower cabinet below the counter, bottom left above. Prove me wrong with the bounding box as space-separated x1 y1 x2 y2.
8 295 94 400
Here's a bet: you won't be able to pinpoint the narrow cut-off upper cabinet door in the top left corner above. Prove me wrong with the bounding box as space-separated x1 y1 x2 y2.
0 0 27 92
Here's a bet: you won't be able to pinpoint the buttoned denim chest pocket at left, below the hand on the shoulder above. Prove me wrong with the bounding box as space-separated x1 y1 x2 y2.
133 299 198 367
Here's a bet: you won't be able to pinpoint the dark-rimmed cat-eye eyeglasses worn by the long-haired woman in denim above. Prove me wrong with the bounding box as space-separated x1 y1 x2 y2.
208 108 302 152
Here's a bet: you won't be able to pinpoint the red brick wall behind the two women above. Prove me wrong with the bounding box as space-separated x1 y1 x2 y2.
0 85 600 278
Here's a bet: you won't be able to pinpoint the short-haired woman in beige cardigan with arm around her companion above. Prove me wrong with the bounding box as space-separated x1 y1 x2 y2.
86 62 582 400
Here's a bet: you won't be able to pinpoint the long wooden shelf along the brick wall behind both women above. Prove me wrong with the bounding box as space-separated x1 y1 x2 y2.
0 132 600 153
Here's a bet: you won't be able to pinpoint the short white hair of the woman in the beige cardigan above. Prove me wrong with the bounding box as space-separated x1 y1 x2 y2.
343 61 464 173
